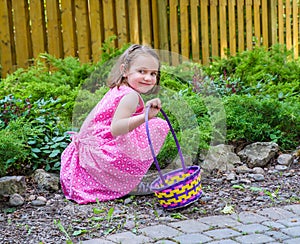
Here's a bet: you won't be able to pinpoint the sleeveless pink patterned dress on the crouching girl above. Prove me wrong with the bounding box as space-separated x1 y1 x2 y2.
60 86 169 204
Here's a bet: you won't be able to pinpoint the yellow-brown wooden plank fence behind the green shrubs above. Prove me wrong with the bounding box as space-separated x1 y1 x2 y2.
0 0 300 77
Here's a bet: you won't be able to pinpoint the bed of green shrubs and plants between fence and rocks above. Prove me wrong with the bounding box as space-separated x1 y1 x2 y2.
0 40 300 176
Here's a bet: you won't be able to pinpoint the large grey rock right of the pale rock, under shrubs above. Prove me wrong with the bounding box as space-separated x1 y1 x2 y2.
238 142 279 168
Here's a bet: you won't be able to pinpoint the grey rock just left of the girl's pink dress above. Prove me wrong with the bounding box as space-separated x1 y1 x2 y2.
33 169 59 191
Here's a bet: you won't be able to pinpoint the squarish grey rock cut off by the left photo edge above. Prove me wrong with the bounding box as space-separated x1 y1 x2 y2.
0 176 26 196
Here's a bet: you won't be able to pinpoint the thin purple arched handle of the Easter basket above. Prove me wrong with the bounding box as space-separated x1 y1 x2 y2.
145 106 186 185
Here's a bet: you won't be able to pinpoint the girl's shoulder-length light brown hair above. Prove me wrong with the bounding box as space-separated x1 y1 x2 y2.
107 44 160 94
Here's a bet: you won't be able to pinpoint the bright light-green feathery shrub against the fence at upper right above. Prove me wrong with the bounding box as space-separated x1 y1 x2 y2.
203 45 300 97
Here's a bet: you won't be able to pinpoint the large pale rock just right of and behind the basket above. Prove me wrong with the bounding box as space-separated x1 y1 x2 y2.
201 144 241 172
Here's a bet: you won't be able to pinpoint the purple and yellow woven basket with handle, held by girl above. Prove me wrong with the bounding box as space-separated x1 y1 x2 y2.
145 106 202 210
